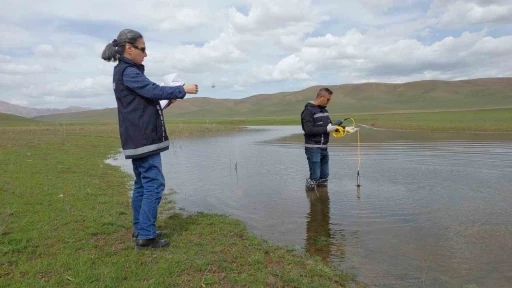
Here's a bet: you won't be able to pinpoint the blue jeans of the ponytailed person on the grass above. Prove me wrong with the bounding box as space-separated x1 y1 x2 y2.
132 153 165 239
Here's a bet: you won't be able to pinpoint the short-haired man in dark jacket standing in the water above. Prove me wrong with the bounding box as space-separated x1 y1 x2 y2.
301 88 343 189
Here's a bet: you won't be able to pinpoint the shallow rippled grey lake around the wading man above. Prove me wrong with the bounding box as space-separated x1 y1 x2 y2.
110 126 512 287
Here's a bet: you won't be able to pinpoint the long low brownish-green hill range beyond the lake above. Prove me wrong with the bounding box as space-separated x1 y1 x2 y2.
33 77 512 121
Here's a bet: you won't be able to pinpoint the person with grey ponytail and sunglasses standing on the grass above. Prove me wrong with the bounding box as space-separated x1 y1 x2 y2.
101 29 198 248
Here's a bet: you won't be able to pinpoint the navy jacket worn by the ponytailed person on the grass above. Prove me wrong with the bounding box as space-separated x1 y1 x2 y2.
113 56 186 159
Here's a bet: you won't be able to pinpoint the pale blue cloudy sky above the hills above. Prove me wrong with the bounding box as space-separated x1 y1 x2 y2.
0 0 512 108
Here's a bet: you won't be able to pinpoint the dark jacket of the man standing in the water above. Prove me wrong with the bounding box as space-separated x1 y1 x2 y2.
300 102 331 148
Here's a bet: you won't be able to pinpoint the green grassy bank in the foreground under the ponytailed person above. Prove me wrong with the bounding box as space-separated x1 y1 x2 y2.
0 123 359 287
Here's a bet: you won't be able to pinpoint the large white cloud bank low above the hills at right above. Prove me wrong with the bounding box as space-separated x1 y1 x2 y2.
263 30 512 81
